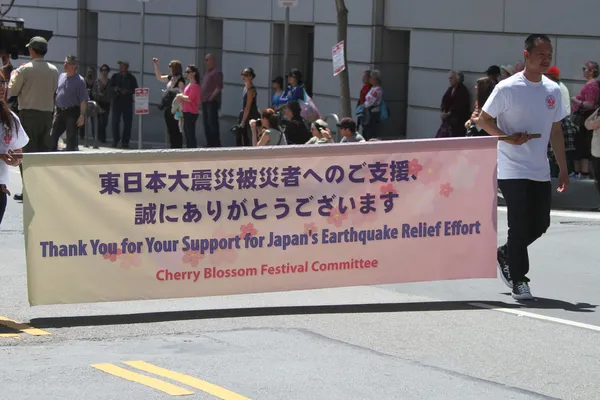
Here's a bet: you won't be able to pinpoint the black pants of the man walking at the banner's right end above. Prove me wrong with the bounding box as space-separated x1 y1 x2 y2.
498 179 552 283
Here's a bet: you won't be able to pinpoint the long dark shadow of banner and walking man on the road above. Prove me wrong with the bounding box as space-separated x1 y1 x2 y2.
30 299 596 329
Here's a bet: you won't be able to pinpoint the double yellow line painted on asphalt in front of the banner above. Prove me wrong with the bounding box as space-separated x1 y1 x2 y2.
92 361 250 400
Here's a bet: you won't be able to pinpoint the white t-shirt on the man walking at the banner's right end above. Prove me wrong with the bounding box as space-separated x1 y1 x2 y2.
483 72 568 182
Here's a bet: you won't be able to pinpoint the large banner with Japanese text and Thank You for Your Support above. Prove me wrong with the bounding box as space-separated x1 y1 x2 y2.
24 138 496 305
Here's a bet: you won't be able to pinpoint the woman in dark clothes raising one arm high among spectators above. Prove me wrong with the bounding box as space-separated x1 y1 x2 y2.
152 57 185 149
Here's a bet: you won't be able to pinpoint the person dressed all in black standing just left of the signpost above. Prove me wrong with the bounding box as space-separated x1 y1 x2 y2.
109 61 138 149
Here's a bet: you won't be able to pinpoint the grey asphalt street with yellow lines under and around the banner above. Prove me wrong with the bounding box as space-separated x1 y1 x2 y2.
0 163 600 400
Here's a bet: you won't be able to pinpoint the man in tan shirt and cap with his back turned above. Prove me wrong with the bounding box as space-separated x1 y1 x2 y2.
8 36 58 200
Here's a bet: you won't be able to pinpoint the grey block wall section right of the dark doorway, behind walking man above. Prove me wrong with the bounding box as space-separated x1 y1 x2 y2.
385 0 600 138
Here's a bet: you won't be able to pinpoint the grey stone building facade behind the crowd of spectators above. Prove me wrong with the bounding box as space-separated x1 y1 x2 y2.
10 0 600 145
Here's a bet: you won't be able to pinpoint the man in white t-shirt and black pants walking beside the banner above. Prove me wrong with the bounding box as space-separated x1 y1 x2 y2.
478 34 569 300
